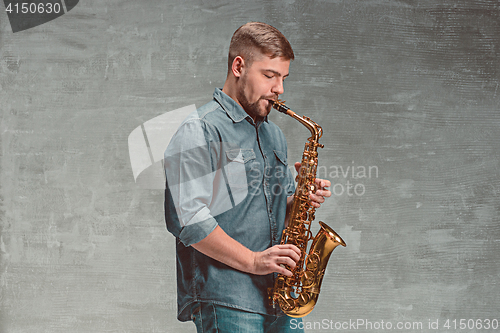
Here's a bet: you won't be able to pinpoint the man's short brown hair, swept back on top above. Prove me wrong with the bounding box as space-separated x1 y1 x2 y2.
228 22 295 70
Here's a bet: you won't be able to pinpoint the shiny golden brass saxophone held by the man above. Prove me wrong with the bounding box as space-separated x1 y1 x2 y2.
269 100 346 318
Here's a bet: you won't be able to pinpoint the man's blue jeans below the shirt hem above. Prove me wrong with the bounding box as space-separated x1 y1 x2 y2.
191 303 304 333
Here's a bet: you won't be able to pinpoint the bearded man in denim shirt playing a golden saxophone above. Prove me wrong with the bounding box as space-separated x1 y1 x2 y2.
164 22 331 332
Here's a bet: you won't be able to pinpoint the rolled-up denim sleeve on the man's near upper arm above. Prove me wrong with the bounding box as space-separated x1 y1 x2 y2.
164 114 218 246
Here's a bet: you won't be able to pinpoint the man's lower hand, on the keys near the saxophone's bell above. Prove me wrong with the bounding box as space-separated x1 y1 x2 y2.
251 244 300 276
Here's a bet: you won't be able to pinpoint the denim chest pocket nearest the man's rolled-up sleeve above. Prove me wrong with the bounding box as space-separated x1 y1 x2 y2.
224 149 255 205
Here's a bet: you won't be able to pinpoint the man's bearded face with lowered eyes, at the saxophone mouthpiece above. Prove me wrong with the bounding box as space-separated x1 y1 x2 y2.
236 55 290 120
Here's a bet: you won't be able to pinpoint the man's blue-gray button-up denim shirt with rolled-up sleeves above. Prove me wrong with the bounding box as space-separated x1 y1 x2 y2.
164 89 295 321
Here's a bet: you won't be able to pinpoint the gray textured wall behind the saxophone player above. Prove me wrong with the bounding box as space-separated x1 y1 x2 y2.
0 0 500 333
